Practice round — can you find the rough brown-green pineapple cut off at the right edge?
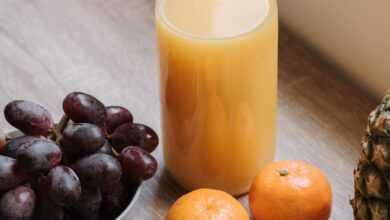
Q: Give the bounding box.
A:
[351,91,390,220]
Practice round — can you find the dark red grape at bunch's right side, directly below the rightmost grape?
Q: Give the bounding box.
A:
[119,147,157,181]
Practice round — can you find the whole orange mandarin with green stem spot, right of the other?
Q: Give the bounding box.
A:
[249,161,332,220]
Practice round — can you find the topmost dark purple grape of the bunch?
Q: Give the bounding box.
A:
[62,92,106,127]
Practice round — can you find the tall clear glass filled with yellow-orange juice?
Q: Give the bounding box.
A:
[156,0,278,195]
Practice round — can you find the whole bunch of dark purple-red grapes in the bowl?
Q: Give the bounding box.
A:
[0,92,159,220]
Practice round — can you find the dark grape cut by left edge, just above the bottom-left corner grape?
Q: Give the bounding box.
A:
[0,155,26,193]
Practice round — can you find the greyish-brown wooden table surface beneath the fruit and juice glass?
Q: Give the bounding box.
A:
[0,0,375,220]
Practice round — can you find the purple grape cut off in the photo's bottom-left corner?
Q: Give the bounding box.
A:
[0,186,36,220]
